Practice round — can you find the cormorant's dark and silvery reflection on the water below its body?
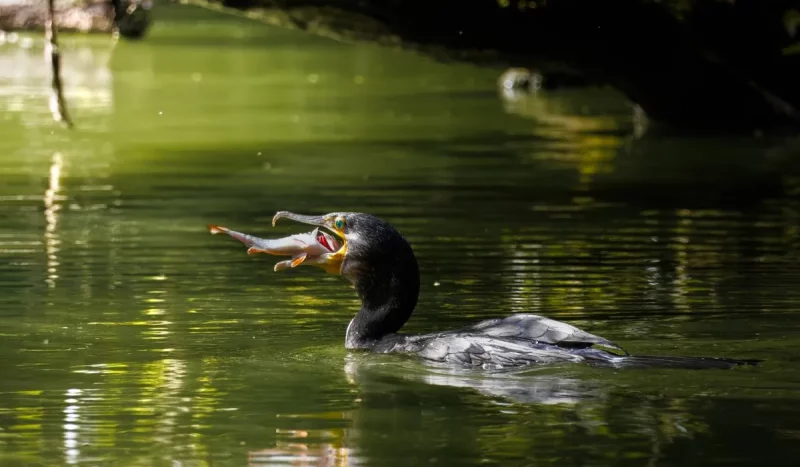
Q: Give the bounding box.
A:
[347,359,724,465]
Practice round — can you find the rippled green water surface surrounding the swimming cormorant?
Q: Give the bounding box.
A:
[0,7,800,466]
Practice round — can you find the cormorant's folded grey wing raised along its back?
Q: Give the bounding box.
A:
[464,314,628,355]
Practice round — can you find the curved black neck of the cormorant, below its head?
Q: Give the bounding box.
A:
[345,229,419,349]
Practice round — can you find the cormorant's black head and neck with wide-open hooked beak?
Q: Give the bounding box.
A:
[272,211,419,348]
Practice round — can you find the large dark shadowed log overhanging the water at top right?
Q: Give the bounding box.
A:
[209,0,800,129]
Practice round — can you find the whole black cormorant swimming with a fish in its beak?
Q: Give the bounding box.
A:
[210,211,758,369]
